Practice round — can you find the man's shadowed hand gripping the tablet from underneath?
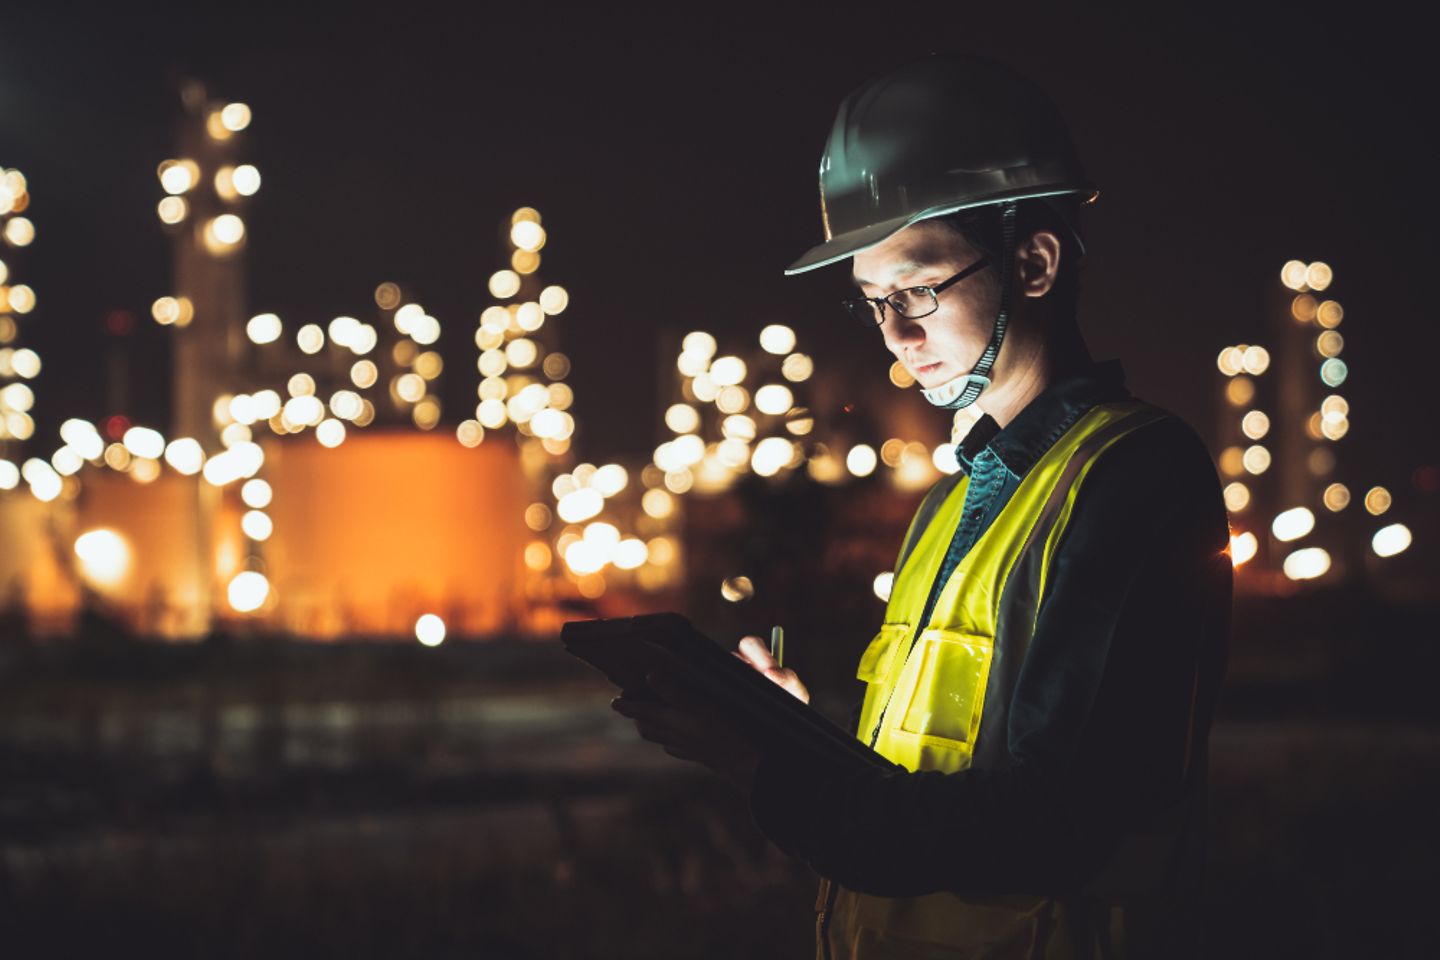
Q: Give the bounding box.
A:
[611,664,760,793]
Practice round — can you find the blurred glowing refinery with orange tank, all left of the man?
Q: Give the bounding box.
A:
[0,81,969,645]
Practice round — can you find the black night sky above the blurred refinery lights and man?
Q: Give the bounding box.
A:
[0,3,1440,486]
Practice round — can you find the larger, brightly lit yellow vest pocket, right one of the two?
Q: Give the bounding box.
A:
[900,629,995,754]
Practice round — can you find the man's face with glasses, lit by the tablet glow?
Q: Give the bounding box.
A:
[852,220,999,389]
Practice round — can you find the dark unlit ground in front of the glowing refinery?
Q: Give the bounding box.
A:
[0,590,1440,960]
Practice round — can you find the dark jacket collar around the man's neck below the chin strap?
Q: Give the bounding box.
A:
[955,360,1130,478]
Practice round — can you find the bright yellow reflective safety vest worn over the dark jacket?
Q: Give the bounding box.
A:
[815,399,1186,960]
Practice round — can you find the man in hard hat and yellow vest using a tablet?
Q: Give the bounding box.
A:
[616,56,1231,959]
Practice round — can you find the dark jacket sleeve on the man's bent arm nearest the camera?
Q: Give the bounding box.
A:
[750,417,1231,897]
